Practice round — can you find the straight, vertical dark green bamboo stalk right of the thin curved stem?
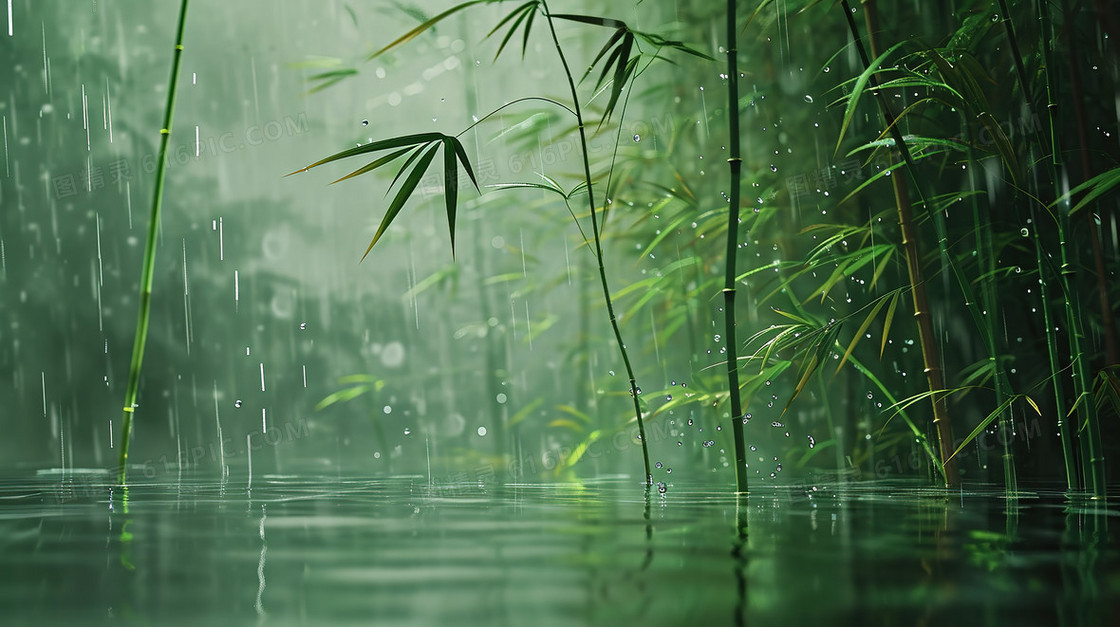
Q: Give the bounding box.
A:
[724,0,747,493]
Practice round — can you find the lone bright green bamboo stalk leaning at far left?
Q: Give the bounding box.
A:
[118,0,187,485]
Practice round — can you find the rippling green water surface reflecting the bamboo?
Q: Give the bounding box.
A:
[0,469,1120,626]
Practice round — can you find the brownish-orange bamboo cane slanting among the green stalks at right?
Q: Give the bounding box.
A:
[841,0,960,486]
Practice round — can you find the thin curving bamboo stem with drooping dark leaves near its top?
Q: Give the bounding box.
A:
[541,0,653,487]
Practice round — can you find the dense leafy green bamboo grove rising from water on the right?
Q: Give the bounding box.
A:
[282,0,1120,496]
